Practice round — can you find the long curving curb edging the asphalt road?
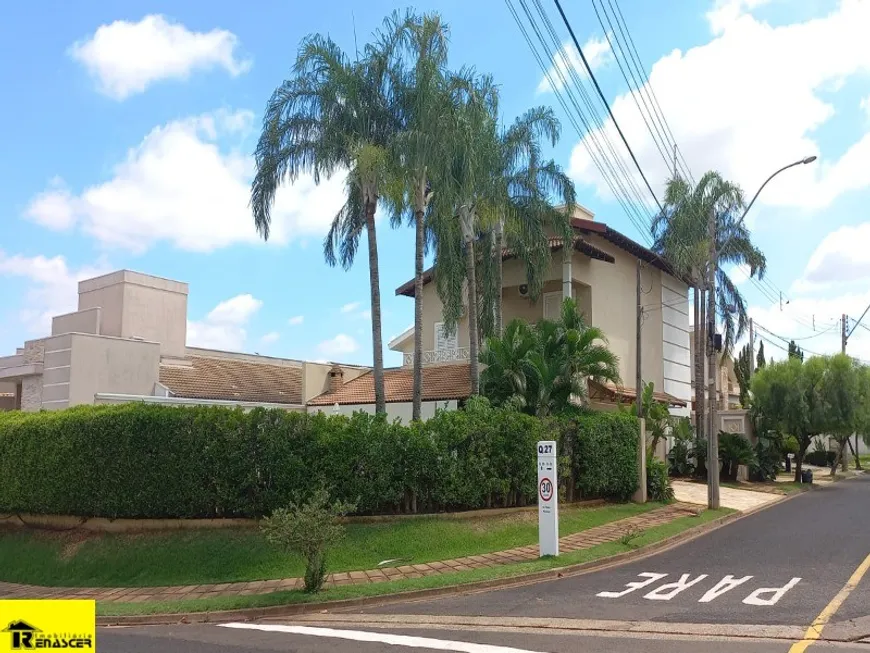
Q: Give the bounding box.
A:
[97,492,806,626]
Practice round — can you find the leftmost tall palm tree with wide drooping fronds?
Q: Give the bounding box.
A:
[251,24,400,413]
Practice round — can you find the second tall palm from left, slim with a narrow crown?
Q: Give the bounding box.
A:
[394,14,450,419]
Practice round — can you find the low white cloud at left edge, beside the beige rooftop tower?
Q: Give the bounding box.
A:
[0,251,111,336]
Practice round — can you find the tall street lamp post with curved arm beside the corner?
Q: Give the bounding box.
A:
[707,155,816,510]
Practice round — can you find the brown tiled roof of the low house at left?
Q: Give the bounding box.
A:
[160,356,302,404]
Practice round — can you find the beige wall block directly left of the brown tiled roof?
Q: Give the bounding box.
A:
[69,334,160,406]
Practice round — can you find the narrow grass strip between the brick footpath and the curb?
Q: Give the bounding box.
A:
[97,508,734,616]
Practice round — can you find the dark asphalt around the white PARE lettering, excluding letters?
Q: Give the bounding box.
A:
[356,477,870,626]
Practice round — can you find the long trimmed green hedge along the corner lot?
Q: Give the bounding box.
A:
[0,400,637,518]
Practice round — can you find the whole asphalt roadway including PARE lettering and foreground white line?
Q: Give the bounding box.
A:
[98,476,870,653]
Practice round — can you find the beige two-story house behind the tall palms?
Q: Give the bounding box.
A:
[316,207,691,415]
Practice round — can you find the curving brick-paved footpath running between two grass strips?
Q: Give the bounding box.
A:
[0,503,698,603]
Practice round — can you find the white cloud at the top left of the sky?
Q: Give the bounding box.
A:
[69,14,251,100]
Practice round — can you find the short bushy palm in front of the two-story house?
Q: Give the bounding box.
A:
[480,299,620,417]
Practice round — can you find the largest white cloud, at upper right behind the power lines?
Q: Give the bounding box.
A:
[570,0,870,216]
